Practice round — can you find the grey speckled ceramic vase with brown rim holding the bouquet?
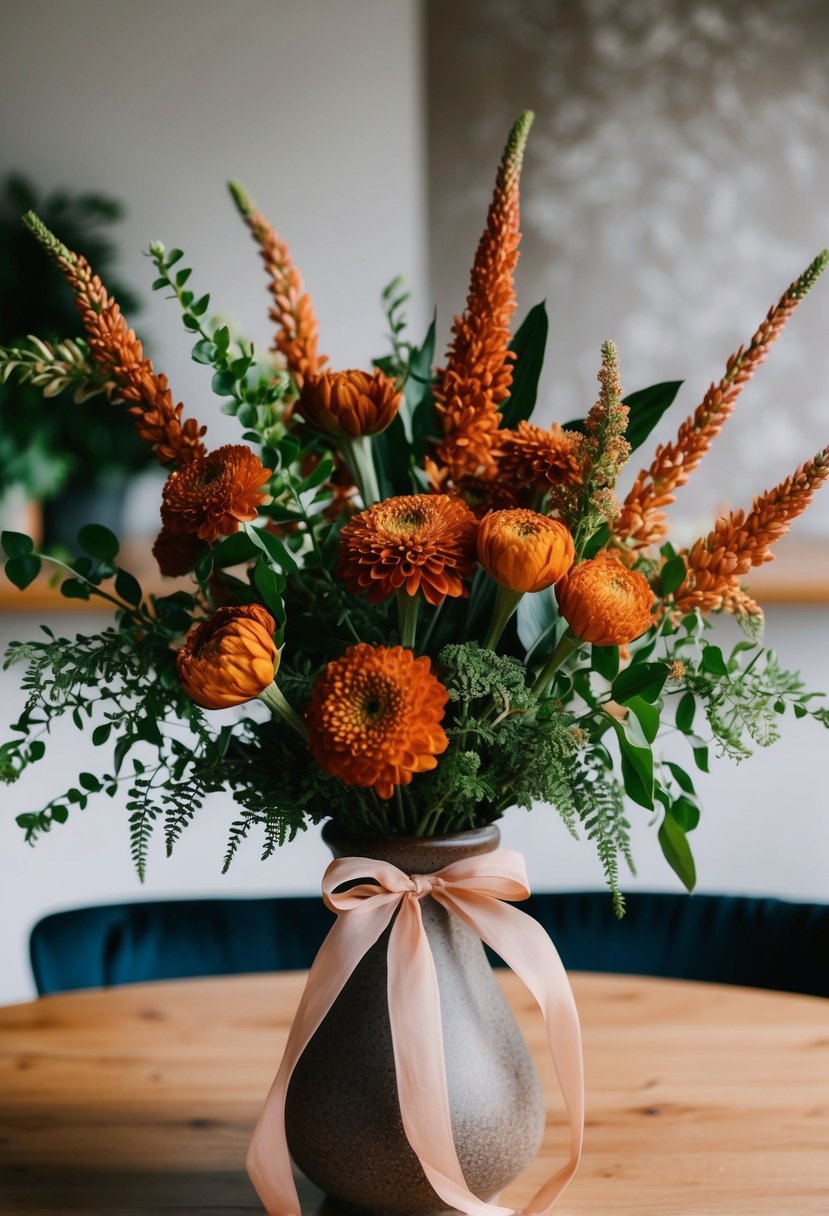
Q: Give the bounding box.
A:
[280,827,545,1216]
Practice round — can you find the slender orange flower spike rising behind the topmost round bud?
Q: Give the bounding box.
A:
[230,181,328,389]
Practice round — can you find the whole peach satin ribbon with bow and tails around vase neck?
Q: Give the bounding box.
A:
[247,849,585,1216]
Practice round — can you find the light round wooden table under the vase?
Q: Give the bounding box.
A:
[0,973,829,1216]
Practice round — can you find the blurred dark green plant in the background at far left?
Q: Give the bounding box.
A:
[0,174,148,547]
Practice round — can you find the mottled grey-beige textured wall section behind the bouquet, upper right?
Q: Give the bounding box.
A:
[427,0,829,536]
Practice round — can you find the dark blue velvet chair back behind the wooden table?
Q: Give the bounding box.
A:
[30,891,829,996]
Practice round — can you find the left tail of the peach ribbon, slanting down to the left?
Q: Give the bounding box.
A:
[247,900,399,1216]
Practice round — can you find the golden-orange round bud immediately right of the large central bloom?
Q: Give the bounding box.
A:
[478,508,575,592]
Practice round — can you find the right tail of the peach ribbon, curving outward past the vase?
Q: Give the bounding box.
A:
[432,888,585,1216]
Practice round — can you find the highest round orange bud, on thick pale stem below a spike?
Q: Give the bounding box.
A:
[298,371,402,439]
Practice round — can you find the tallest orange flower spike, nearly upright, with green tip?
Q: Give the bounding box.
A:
[435,111,534,482]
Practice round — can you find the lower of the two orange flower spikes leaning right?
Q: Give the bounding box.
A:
[673,446,829,613]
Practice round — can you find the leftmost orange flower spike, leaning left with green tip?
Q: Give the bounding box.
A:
[23,212,207,466]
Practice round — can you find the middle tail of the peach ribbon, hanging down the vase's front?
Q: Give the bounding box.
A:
[388,897,513,1216]
